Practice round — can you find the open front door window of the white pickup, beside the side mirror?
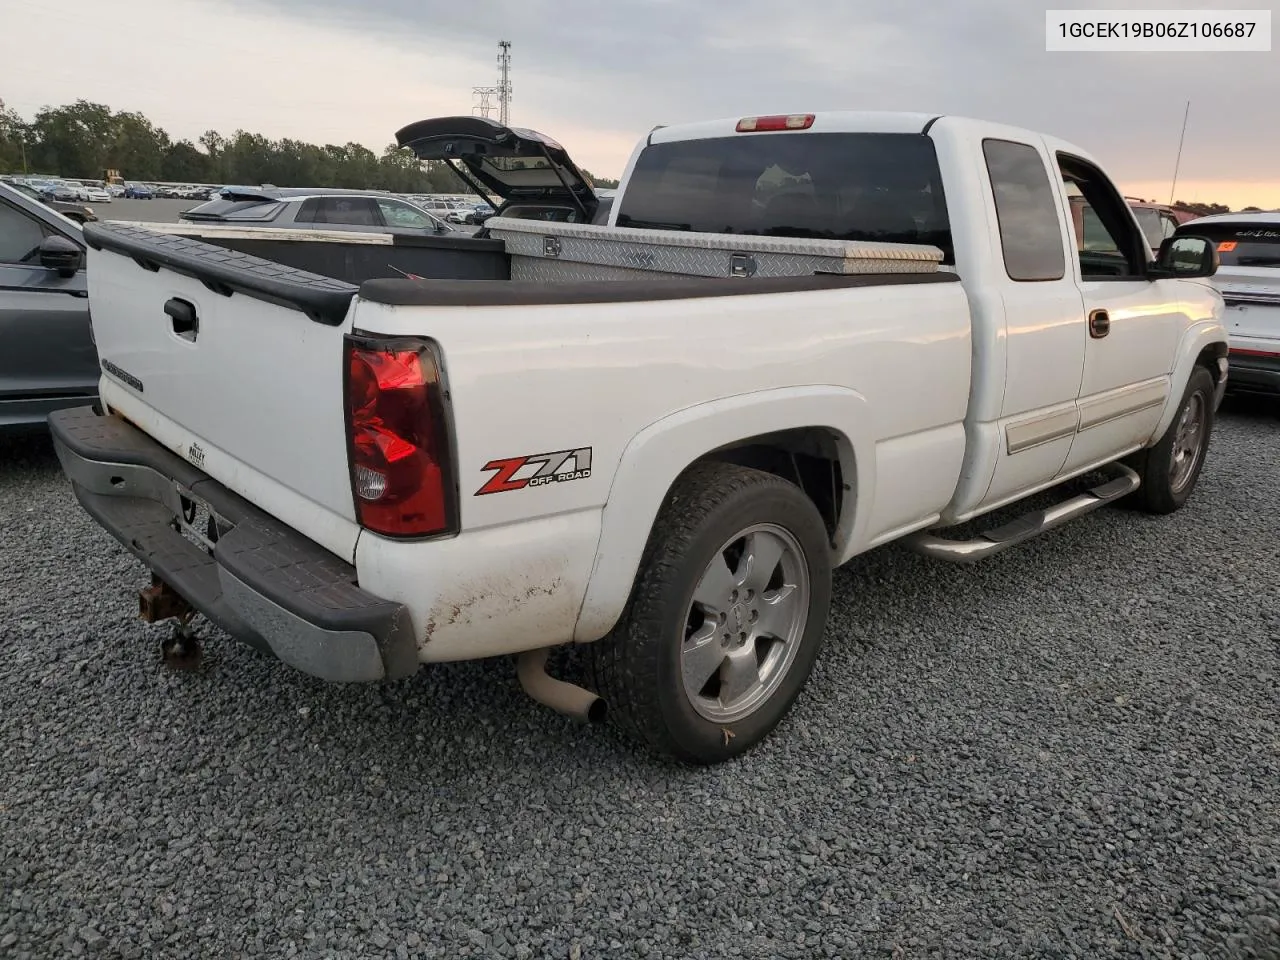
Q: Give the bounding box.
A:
[1057,154,1151,280]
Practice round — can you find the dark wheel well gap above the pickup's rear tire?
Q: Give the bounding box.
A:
[698,426,854,536]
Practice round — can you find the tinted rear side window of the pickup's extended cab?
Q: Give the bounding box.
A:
[982,140,1066,280]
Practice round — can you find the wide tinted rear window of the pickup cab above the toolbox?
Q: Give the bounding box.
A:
[617,133,954,264]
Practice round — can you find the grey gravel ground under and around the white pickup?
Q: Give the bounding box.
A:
[0,406,1280,960]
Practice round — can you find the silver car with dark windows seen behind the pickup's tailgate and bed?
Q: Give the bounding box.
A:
[180,187,453,237]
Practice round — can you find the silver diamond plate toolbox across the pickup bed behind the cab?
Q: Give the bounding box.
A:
[485,216,942,280]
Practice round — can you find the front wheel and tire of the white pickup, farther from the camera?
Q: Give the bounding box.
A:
[1128,366,1215,513]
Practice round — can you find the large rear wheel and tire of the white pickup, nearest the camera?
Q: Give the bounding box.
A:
[590,462,831,764]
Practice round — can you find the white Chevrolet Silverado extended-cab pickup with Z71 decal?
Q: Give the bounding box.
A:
[50,113,1228,763]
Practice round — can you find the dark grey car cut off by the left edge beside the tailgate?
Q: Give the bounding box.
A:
[0,184,100,428]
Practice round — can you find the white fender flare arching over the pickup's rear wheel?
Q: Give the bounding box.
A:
[573,385,876,643]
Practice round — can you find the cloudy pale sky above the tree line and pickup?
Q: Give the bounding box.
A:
[0,0,1280,209]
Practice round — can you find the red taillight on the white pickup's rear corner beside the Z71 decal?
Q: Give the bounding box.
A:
[343,335,458,538]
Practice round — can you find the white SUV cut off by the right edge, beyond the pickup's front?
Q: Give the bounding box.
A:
[1176,211,1280,396]
